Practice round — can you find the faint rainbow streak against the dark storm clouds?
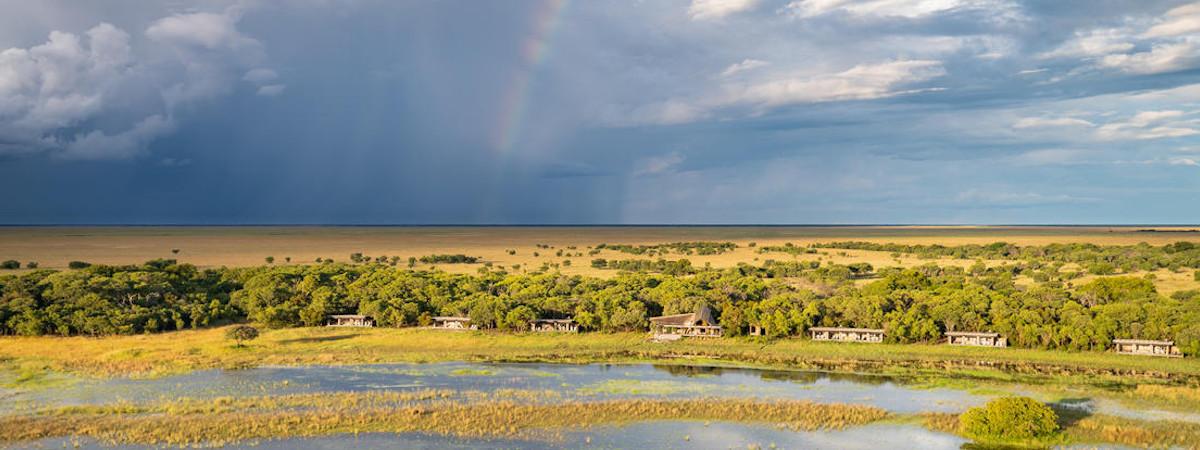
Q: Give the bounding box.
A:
[492,0,570,152]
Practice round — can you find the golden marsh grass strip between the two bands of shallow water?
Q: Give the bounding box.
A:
[0,391,888,445]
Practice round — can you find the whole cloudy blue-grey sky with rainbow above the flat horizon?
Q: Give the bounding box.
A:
[0,0,1200,224]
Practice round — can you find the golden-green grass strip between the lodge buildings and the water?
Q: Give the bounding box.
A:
[0,328,1200,388]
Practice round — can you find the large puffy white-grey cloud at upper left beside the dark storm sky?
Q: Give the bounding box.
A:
[0,8,282,160]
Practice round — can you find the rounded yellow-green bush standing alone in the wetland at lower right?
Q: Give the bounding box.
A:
[959,397,1058,439]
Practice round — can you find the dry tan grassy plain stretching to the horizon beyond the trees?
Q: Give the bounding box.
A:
[0,227,1200,294]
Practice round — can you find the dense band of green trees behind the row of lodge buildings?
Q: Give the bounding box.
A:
[0,260,1200,355]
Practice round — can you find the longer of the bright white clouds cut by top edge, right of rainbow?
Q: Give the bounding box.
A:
[782,0,1003,18]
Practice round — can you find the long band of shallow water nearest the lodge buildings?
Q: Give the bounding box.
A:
[0,362,986,413]
